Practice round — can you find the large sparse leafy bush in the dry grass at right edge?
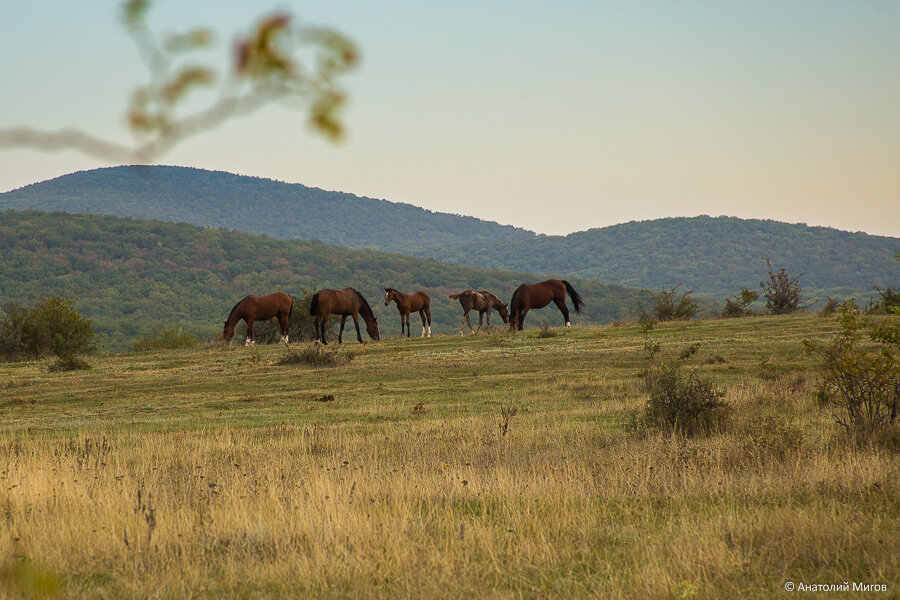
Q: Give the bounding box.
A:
[803,300,900,440]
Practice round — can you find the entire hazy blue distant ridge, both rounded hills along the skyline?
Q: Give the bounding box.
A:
[0,166,900,299]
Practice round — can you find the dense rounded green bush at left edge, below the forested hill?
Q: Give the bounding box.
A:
[0,296,95,361]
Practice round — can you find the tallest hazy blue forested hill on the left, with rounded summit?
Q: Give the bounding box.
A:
[0,166,535,250]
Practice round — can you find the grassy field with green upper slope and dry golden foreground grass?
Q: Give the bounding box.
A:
[0,316,900,598]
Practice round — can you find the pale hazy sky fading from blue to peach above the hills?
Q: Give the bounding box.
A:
[0,0,900,236]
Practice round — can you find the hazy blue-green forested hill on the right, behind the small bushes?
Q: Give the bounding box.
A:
[410,216,900,298]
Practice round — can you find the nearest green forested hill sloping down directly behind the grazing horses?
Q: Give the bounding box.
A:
[0,211,644,349]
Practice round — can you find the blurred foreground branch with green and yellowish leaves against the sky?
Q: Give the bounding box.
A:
[0,0,359,163]
